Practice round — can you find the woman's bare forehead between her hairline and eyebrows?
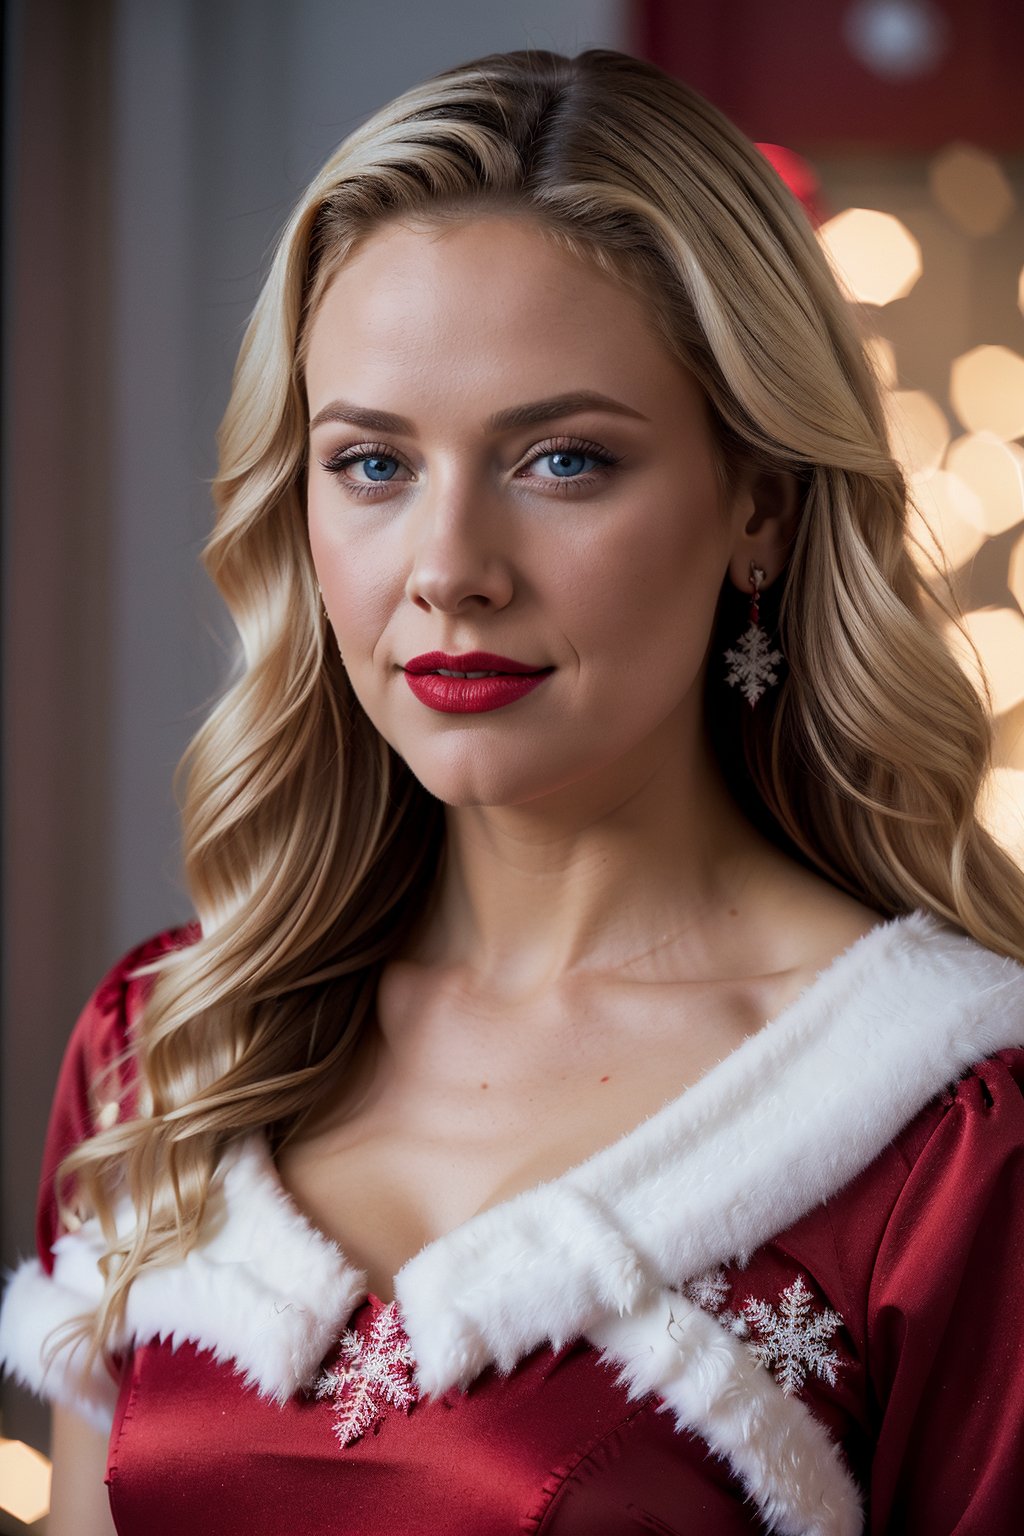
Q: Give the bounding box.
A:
[306,215,700,433]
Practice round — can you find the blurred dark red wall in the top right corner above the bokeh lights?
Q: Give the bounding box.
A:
[631,0,1024,154]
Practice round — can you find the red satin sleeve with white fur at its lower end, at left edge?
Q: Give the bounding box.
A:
[0,928,197,1427]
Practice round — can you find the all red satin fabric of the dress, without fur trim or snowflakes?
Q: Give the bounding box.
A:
[38,935,1024,1536]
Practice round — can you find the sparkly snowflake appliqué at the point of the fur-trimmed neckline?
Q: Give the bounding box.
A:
[316,1301,419,1445]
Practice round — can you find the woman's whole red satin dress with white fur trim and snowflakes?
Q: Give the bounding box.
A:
[0,912,1024,1536]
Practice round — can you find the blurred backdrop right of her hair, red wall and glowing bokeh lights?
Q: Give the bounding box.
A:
[641,0,1024,857]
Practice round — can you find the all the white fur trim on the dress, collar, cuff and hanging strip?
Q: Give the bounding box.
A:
[0,912,1024,1536]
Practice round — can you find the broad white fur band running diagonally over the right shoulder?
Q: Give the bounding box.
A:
[395,912,1024,1393]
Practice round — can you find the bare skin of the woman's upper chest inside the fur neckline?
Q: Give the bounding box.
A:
[278,968,798,1299]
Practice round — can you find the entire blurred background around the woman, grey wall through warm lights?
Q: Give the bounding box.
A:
[0,0,1024,1531]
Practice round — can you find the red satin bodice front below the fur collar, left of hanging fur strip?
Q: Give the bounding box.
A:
[107,1301,760,1536]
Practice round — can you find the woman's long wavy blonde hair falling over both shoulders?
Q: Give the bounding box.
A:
[60,49,1024,1355]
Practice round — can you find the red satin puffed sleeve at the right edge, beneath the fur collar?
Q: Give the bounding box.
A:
[867,1049,1024,1536]
